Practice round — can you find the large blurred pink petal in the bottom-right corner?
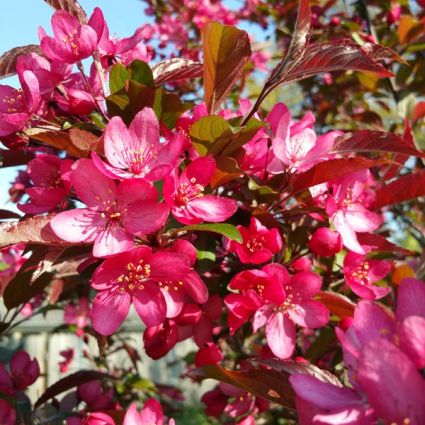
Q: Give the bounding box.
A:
[358,339,425,425]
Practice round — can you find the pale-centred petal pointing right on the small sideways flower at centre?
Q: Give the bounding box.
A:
[187,195,238,223]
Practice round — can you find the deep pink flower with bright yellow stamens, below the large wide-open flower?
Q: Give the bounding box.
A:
[92,246,190,335]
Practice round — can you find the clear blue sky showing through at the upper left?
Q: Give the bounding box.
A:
[0,0,152,210]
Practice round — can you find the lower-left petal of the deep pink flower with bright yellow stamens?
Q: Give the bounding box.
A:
[92,290,131,335]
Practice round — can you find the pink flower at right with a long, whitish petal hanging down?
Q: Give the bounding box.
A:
[326,170,382,254]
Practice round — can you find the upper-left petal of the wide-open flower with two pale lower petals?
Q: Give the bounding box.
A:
[71,159,116,211]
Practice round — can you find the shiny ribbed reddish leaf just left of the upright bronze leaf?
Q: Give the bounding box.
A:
[152,58,203,86]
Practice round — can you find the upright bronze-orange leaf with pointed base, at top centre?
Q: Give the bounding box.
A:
[201,22,251,113]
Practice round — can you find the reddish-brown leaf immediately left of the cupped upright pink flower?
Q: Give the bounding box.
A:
[25,127,100,158]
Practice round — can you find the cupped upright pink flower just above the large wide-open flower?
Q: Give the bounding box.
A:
[92,108,183,181]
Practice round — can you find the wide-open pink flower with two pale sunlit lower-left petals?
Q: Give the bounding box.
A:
[51,159,169,257]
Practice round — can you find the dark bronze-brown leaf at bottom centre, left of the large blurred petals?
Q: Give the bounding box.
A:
[188,364,295,409]
